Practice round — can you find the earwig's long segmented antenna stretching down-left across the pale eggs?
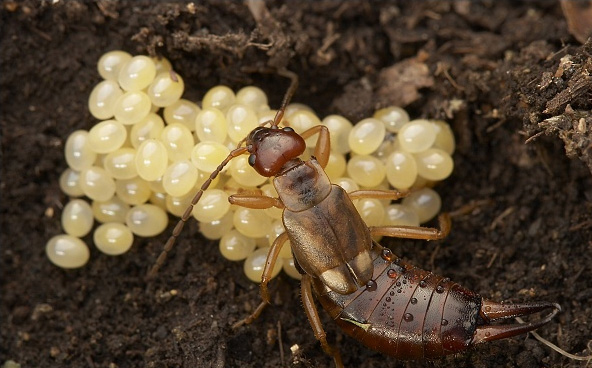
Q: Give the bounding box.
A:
[148,145,247,279]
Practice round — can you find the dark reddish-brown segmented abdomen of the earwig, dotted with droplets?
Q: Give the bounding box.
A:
[314,245,482,359]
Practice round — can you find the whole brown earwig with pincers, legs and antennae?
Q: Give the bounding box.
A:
[150,71,561,367]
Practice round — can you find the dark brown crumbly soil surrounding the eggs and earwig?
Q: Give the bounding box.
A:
[0,0,592,368]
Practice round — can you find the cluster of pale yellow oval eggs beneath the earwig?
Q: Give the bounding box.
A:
[46,51,454,282]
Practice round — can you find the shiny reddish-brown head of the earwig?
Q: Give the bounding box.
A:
[246,126,306,177]
